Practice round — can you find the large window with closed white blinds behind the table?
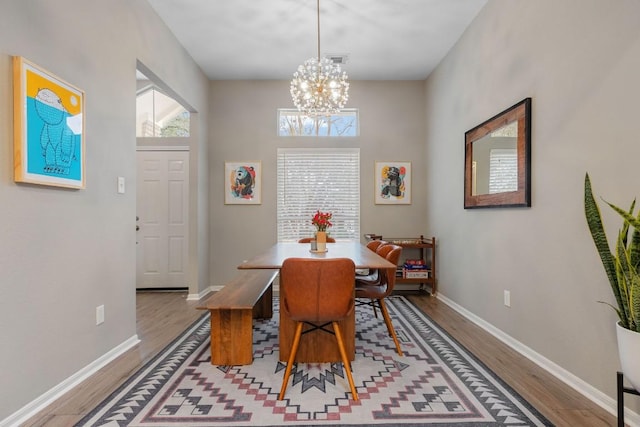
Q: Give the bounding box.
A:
[277,148,360,242]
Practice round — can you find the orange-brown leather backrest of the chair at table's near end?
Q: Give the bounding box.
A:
[280,258,356,322]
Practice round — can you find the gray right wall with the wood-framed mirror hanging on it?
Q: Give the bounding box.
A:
[424,0,640,412]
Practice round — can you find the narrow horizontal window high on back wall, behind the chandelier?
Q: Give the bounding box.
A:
[278,108,359,137]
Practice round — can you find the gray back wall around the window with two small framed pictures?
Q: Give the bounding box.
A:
[209,81,429,285]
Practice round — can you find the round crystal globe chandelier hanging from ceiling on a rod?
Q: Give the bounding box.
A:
[290,0,349,116]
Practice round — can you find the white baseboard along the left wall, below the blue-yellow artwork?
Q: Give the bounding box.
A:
[0,335,140,427]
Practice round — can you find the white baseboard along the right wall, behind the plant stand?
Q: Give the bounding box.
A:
[438,293,640,427]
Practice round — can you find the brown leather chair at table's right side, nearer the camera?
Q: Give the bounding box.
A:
[356,244,402,356]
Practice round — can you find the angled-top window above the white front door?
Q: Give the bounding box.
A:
[136,85,190,138]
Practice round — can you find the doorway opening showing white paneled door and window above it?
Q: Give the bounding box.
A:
[136,61,194,291]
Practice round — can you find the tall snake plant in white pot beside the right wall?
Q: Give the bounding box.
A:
[584,174,640,390]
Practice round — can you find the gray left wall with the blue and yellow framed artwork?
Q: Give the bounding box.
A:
[0,0,208,420]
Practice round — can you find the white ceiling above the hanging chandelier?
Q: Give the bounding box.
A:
[148,0,487,80]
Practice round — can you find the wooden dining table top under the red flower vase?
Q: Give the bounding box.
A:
[238,242,396,270]
